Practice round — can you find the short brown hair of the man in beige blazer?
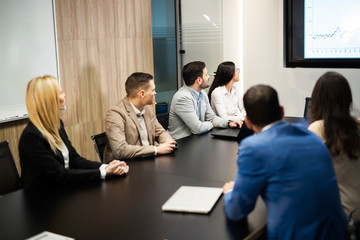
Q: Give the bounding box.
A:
[125,72,154,97]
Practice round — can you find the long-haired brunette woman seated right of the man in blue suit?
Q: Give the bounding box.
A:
[309,72,360,218]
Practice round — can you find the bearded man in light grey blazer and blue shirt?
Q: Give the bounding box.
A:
[169,61,242,139]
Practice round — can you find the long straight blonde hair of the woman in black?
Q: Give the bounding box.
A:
[26,75,63,153]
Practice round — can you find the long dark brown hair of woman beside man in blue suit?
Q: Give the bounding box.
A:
[311,72,360,159]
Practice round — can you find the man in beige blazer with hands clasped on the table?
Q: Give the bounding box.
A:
[104,72,176,162]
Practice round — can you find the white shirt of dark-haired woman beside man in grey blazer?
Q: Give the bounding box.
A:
[211,85,246,121]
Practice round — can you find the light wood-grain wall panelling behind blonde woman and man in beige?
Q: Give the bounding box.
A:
[0,0,154,174]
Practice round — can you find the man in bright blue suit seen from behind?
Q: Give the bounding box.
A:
[223,85,346,239]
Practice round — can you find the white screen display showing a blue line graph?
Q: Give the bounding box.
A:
[304,0,360,58]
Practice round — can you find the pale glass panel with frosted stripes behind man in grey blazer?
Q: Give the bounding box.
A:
[179,0,223,89]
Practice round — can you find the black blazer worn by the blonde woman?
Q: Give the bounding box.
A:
[19,120,101,188]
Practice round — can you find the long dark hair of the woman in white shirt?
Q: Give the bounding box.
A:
[208,62,235,101]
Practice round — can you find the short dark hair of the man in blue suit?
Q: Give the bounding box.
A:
[244,84,282,127]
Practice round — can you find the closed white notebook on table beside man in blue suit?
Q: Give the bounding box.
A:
[162,186,222,214]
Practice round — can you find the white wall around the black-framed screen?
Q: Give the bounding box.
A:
[223,0,360,117]
